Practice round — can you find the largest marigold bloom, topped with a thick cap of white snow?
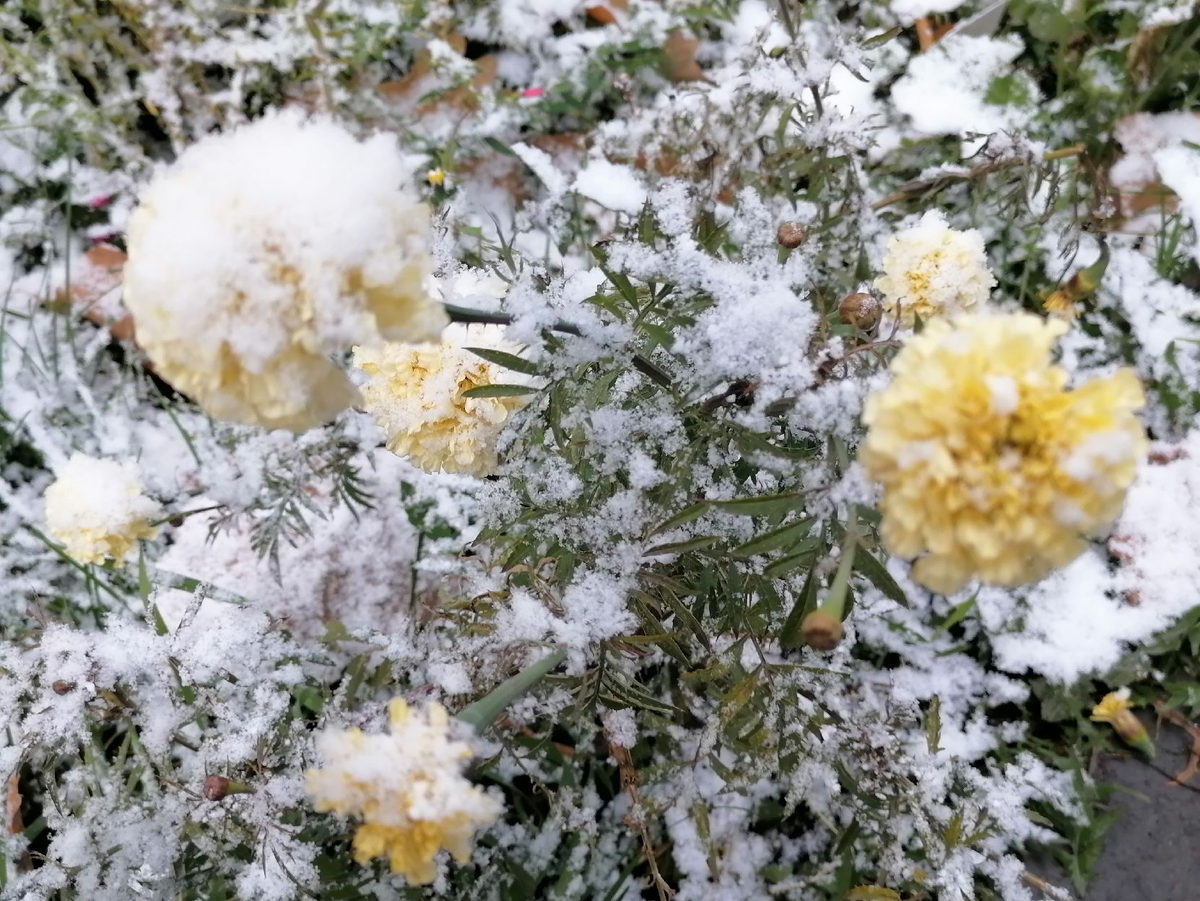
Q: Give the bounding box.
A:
[125,112,445,431]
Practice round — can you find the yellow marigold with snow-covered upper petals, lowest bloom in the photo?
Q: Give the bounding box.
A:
[307,698,502,885]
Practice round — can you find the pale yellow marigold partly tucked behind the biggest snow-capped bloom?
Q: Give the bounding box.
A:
[354,325,528,475]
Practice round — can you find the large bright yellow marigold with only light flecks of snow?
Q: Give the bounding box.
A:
[860,313,1146,594]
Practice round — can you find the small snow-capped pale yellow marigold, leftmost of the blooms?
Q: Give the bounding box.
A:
[46,453,160,563]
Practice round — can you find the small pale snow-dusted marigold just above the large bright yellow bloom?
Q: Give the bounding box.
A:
[875,210,996,325]
